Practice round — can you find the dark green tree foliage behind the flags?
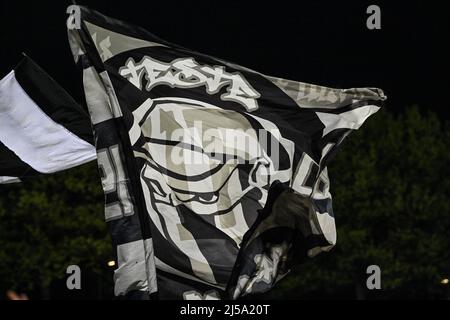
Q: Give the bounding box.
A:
[0,107,450,299]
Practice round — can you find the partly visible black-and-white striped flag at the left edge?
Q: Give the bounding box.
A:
[0,56,96,184]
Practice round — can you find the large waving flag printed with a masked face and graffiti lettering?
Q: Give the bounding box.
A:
[68,7,386,300]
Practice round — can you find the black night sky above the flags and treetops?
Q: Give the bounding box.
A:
[0,0,450,119]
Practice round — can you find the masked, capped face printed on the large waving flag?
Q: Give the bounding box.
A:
[133,98,294,280]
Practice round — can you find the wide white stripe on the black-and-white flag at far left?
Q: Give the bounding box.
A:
[0,71,96,173]
